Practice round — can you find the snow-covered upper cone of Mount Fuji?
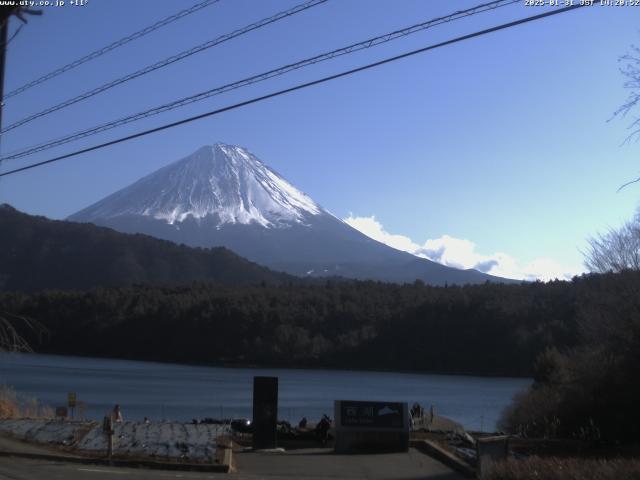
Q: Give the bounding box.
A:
[76,143,326,228]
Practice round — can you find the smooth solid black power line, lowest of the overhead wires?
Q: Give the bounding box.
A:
[0,3,589,177]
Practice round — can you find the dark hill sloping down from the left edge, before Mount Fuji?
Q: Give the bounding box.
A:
[0,204,295,291]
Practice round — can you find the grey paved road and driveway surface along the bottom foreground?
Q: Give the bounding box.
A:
[0,449,463,480]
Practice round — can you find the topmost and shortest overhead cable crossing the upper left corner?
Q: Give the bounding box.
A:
[3,0,220,100]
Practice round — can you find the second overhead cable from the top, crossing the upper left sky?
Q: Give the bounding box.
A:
[0,0,328,134]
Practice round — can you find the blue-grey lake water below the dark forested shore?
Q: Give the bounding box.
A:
[0,353,531,431]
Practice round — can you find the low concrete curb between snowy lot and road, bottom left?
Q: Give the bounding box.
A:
[0,449,232,473]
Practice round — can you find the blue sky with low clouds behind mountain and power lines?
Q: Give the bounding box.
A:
[0,0,640,278]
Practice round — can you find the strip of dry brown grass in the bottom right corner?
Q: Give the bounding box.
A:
[488,457,640,480]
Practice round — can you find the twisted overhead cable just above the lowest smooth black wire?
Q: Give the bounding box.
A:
[0,0,520,162]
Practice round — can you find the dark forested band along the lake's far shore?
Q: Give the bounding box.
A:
[5,272,640,375]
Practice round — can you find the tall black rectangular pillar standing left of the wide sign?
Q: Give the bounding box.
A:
[253,377,278,449]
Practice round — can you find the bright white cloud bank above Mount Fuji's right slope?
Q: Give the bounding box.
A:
[344,214,583,281]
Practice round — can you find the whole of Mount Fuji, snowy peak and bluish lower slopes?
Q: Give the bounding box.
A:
[68,143,508,285]
